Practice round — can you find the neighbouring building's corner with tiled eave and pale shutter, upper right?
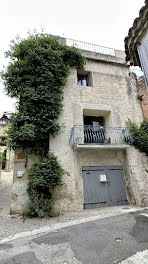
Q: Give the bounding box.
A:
[125,0,148,89]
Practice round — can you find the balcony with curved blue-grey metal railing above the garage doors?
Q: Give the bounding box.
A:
[69,126,133,149]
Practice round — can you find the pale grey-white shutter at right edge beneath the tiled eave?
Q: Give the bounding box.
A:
[138,40,148,89]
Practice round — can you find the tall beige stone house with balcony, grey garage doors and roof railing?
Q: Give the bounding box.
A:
[11,37,148,213]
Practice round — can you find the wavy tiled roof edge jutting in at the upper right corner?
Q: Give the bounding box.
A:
[124,0,148,65]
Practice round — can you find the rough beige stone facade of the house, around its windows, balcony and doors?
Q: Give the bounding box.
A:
[11,46,148,212]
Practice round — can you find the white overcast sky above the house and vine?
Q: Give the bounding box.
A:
[0,0,145,117]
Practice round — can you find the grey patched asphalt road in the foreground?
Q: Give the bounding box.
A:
[0,209,148,264]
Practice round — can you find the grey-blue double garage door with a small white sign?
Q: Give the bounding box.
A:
[83,166,127,208]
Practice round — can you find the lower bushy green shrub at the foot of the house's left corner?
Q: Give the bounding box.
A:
[24,153,66,217]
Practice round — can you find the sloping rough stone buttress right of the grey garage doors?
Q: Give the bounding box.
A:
[125,146,148,206]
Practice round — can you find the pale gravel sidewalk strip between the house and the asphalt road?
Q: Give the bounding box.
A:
[0,172,147,240]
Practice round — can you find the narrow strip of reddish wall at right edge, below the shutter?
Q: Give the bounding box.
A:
[138,76,148,121]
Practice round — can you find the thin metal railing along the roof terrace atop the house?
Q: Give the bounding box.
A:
[66,39,115,56]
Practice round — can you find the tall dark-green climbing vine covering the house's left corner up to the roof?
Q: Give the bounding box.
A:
[2,34,85,216]
